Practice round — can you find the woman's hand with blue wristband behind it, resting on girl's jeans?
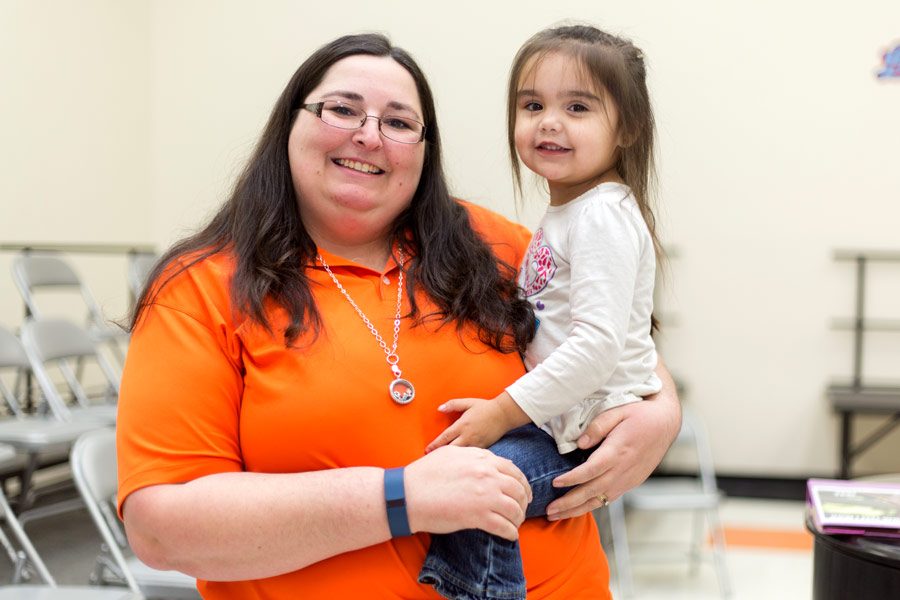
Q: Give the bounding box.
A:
[404,446,531,540]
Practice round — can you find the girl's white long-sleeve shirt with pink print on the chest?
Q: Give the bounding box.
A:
[506,183,662,453]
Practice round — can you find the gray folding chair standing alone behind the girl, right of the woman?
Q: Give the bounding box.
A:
[609,407,732,598]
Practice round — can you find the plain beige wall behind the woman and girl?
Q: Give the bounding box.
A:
[0,0,900,476]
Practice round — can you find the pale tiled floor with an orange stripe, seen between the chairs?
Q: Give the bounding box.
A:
[0,482,812,600]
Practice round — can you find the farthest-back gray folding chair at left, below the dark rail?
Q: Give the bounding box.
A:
[12,252,129,368]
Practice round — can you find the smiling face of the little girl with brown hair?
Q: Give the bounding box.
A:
[514,52,621,205]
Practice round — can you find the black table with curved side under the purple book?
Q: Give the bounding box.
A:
[806,515,900,600]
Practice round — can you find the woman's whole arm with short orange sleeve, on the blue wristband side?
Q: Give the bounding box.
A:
[117,256,530,580]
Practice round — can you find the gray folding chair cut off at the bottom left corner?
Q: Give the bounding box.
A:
[0,444,142,600]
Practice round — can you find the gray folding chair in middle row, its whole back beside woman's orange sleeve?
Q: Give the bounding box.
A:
[21,319,119,425]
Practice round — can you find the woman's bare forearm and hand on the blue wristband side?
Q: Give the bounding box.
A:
[123,447,531,581]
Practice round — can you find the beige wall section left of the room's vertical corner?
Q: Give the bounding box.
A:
[0,0,156,327]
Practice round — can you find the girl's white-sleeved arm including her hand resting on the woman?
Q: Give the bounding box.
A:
[426,199,655,451]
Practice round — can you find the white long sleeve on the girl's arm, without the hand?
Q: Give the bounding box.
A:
[506,197,655,426]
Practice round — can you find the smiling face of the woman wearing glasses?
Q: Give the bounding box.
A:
[288,55,428,253]
